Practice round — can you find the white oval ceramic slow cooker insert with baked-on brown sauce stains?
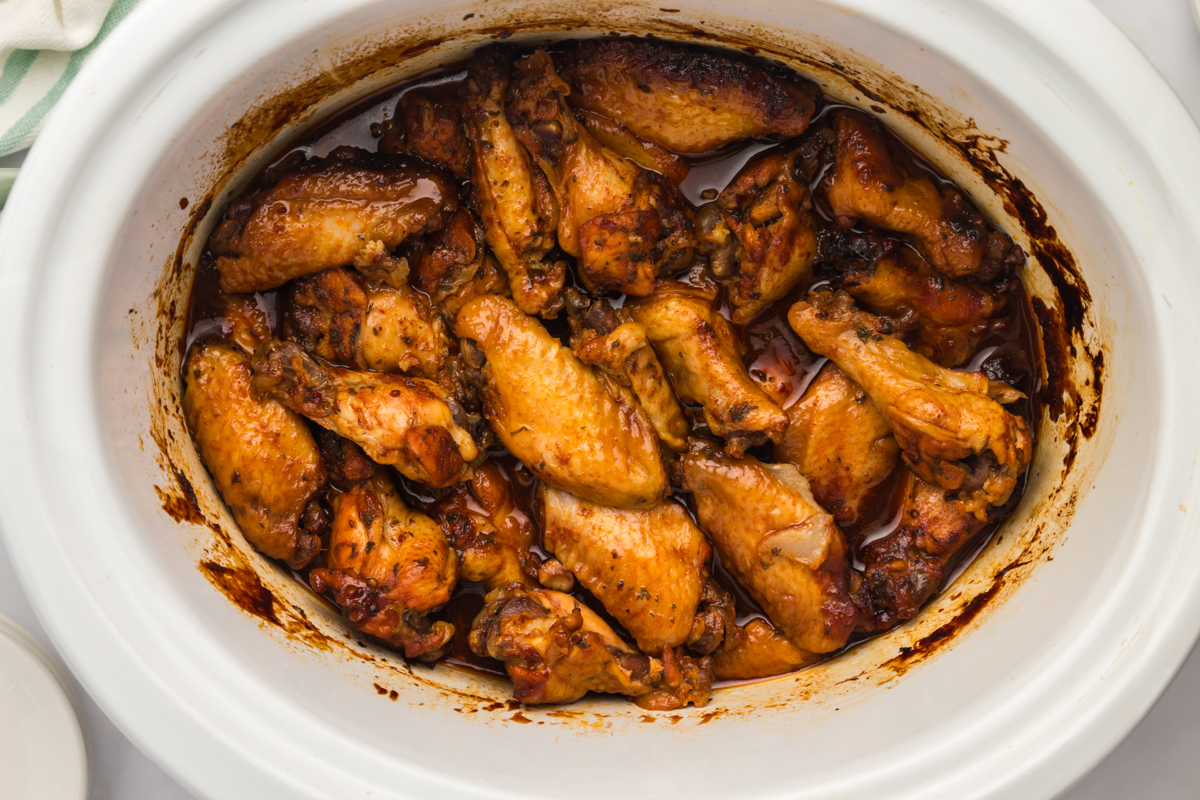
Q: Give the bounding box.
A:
[0,0,1200,800]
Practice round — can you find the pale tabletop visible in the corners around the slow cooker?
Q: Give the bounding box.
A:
[0,0,1200,800]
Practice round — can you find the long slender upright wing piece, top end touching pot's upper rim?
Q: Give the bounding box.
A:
[463,46,566,317]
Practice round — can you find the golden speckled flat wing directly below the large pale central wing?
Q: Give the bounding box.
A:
[538,486,724,655]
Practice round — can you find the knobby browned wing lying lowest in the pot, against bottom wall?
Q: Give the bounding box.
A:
[470,587,713,710]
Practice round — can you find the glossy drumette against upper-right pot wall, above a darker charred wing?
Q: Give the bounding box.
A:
[821,109,1025,281]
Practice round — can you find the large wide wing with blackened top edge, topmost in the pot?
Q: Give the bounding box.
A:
[558,38,820,155]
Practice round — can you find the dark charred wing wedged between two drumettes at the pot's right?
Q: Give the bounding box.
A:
[839,241,1008,367]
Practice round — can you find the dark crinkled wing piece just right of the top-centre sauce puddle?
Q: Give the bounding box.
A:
[696,152,817,325]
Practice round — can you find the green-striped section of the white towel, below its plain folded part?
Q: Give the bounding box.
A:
[0,0,138,158]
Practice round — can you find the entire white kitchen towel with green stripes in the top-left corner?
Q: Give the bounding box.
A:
[0,0,138,156]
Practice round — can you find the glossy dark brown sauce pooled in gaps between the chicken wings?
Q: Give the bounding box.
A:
[180,47,1042,686]
